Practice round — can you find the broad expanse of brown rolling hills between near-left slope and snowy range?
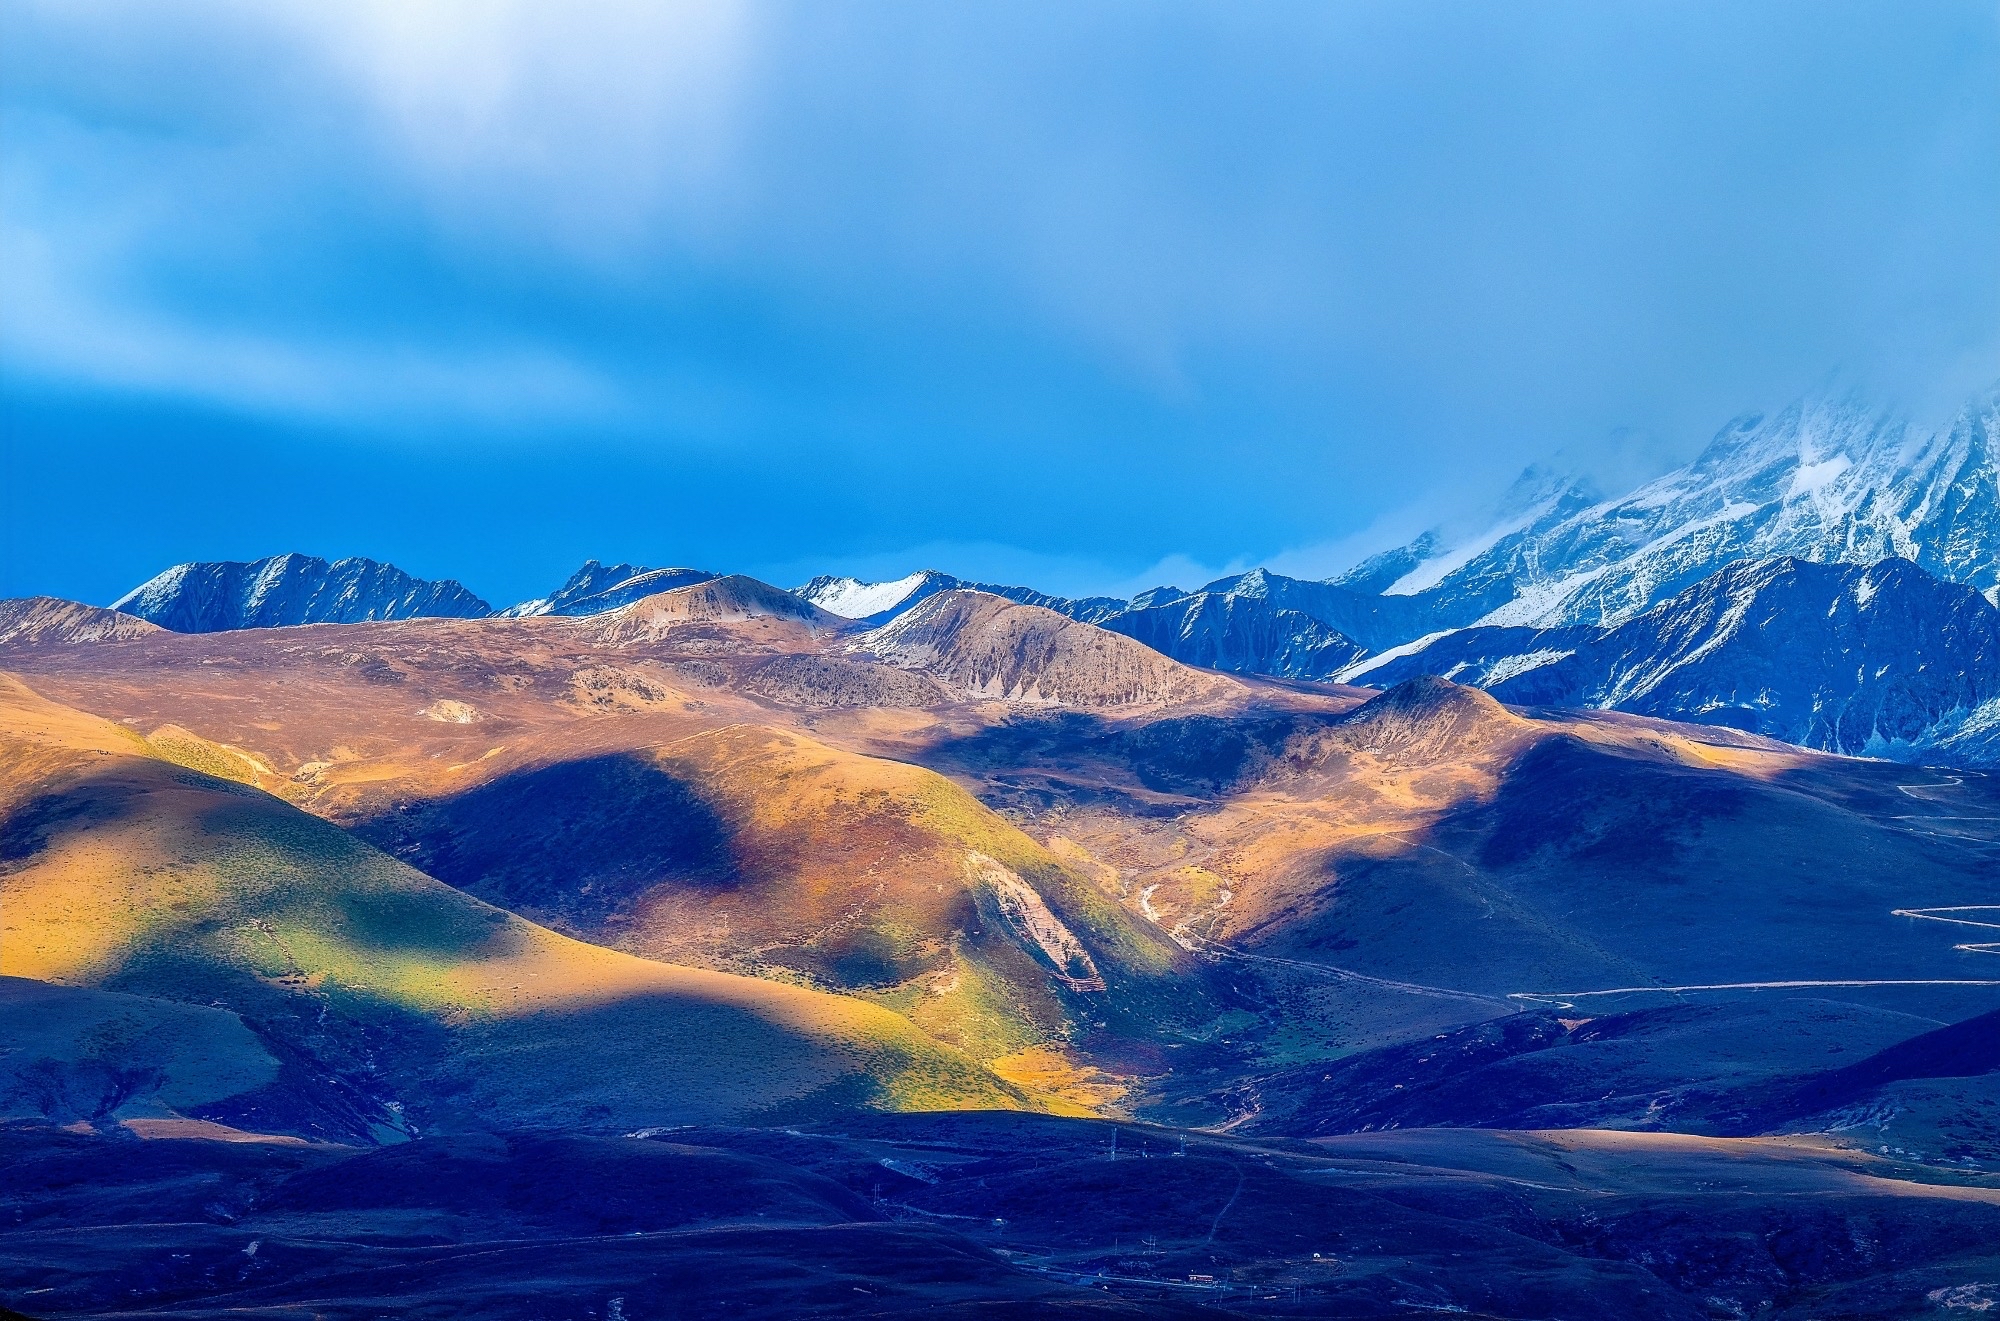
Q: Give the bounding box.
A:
[8,580,2000,1123]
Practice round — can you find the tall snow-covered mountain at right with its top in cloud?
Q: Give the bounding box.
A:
[1334,388,2000,628]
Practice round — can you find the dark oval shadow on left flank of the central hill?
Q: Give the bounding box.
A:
[354,753,740,925]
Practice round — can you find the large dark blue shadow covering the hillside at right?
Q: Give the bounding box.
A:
[1248,737,2000,993]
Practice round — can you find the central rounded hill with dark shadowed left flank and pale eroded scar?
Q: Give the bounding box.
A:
[368,725,1202,1059]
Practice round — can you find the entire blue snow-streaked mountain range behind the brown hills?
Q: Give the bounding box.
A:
[78,378,2000,765]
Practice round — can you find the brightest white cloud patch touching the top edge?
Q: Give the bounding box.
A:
[278,0,756,256]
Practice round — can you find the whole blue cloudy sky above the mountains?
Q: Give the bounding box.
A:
[0,0,2000,602]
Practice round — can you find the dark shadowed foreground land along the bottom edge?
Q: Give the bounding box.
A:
[0,1115,2000,1321]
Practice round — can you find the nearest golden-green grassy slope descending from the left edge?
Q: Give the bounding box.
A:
[0,681,1028,1125]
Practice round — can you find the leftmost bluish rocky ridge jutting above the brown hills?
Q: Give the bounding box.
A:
[112,554,492,632]
